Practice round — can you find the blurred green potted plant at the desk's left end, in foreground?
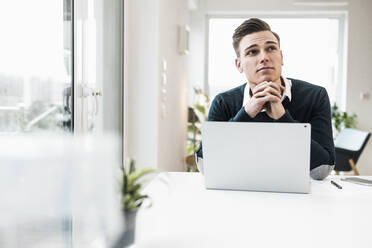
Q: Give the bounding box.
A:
[114,159,154,248]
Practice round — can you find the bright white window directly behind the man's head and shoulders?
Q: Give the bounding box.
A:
[207,16,345,105]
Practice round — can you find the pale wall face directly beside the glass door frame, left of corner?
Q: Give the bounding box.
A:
[124,0,159,167]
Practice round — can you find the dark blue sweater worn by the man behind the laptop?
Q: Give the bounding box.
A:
[197,79,335,169]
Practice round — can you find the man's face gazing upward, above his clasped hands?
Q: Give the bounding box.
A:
[235,31,283,88]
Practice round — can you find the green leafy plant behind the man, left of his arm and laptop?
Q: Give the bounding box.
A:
[186,88,210,172]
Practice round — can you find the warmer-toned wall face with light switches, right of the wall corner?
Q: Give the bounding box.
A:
[158,0,188,171]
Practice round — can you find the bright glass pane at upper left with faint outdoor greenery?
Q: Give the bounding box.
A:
[0,0,72,133]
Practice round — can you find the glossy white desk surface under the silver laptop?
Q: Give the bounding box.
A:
[136,173,372,248]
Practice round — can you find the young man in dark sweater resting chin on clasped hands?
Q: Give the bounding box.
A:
[197,18,335,180]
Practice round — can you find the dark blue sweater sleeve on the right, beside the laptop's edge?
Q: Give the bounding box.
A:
[277,88,335,173]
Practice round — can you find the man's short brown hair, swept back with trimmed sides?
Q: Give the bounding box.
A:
[232,18,280,57]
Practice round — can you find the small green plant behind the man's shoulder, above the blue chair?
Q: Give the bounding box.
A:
[331,103,357,137]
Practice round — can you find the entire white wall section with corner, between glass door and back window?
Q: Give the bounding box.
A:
[124,0,187,171]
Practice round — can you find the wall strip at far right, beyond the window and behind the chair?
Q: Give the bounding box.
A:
[346,0,372,175]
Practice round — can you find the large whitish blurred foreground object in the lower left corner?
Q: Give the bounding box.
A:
[0,135,122,248]
